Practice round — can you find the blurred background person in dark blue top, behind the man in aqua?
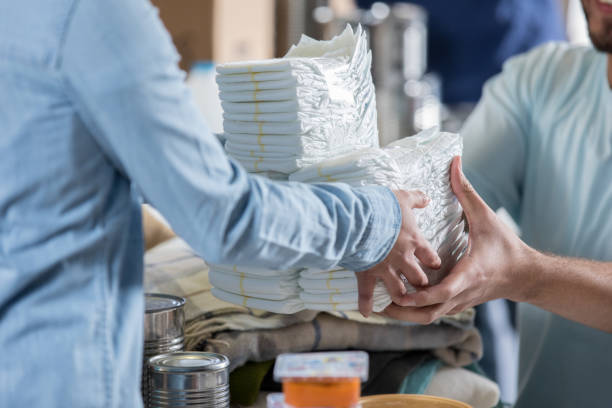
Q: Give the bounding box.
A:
[356,0,565,400]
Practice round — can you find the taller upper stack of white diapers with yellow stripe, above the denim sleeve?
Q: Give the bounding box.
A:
[217,26,378,174]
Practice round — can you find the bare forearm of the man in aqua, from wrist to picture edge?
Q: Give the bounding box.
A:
[514,250,612,332]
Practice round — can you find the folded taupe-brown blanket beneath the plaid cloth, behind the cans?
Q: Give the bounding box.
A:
[203,313,482,370]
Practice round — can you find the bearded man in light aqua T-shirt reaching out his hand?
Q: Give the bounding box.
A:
[388,0,612,407]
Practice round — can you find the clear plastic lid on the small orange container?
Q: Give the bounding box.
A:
[274,351,368,381]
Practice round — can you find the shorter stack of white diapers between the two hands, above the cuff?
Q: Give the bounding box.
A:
[289,128,468,290]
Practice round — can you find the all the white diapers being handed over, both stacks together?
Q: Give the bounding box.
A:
[209,26,467,313]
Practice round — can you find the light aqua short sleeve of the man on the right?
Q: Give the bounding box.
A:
[461,48,534,220]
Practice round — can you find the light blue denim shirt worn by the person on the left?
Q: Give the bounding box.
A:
[0,0,401,408]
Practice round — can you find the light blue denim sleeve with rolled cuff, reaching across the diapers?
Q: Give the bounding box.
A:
[58,0,401,271]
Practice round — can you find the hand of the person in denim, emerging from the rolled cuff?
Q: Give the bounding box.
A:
[357,190,441,317]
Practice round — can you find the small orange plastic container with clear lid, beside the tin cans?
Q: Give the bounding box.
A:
[274,351,368,408]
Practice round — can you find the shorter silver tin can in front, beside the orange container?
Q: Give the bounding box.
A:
[149,352,230,408]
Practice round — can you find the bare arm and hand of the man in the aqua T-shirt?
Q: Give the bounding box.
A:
[386,158,612,332]
